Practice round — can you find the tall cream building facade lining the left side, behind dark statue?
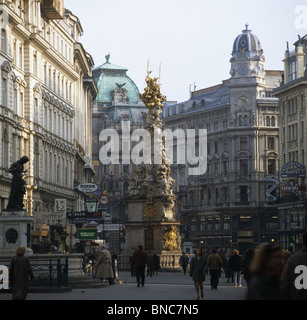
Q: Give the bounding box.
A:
[0,0,97,254]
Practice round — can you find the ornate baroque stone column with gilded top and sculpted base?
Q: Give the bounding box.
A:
[124,71,181,256]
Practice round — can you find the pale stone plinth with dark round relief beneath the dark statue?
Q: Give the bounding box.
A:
[0,210,34,255]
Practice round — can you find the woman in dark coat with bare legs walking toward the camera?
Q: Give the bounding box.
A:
[190,248,207,300]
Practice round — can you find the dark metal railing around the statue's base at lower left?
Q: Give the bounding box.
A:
[0,258,68,288]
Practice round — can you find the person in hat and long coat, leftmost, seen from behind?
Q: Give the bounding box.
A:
[9,247,34,300]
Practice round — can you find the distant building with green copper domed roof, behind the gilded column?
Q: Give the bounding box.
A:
[93,55,147,235]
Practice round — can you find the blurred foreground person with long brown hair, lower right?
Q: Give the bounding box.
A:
[247,243,281,300]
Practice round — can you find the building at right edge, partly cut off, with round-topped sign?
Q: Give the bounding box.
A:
[274,35,307,249]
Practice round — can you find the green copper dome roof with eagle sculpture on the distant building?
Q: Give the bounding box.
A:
[93,55,140,105]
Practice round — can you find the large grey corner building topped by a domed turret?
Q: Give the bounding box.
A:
[163,26,282,252]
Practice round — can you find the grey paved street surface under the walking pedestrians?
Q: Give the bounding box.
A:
[0,272,247,302]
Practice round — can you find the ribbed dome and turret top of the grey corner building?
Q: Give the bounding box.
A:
[230,24,265,81]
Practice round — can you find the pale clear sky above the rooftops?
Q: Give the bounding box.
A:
[64,0,307,102]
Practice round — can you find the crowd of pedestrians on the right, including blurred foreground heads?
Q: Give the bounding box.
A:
[184,233,307,300]
